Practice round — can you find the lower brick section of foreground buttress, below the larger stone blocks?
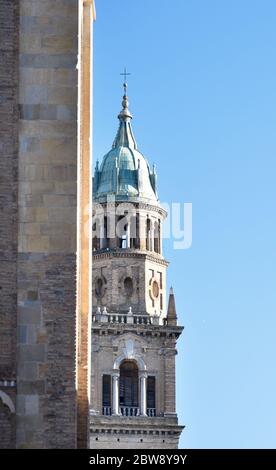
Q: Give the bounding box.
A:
[17,253,76,448]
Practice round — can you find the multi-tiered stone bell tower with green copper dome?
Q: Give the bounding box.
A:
[90,83,183,449]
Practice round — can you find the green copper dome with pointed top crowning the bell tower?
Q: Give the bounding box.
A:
[93,94,158,202]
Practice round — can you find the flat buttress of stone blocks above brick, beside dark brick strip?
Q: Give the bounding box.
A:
[17,0,78,448]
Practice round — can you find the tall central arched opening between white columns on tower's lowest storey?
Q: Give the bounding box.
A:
[120,360,139,416]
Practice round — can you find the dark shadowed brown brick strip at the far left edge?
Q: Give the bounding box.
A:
[0,0,19,448]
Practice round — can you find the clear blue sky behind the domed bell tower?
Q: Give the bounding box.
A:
[94,0,276,448]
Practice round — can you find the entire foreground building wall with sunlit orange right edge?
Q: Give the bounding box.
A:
[0,0,93,448]
